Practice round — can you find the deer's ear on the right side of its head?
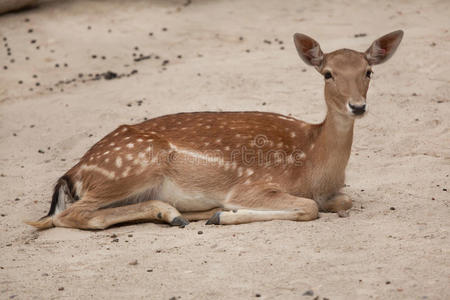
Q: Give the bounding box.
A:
[365,30,403,65]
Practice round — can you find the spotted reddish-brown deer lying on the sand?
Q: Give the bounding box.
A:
[28,30,403,229]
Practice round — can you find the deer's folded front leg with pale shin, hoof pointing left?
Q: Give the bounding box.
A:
[206,192,319,225]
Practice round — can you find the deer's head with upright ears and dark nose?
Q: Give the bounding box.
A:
[294,30,403,119]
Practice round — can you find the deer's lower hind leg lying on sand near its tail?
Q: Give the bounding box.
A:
[53,200,189,229]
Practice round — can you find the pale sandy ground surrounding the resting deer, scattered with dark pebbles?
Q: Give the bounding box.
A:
[0,0,450,299]
